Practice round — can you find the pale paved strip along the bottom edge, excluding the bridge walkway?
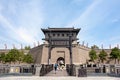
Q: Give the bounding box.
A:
[0,76,120,80]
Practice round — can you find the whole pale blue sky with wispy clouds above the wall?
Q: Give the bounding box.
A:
[0,0,120,48]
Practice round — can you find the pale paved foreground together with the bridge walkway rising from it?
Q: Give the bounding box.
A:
[0,70,120,80]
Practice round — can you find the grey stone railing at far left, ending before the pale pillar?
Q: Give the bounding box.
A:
[0,64,36,75]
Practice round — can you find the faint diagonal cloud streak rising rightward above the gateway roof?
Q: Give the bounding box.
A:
[67,0,102,30]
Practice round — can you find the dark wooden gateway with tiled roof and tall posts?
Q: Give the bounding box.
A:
[42,28,80,64]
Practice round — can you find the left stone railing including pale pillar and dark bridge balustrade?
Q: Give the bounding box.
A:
[0,64,53,76]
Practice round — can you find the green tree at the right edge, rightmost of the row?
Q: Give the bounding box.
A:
[110,47,120,64]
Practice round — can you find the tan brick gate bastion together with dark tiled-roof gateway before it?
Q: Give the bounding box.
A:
[30,28,89,64]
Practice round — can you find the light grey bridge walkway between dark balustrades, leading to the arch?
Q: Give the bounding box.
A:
[45,69,68,77]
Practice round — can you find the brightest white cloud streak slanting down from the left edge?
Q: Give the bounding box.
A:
[0,15,41,47]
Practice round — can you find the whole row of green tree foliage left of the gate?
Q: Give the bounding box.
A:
[0,49,33,63]
